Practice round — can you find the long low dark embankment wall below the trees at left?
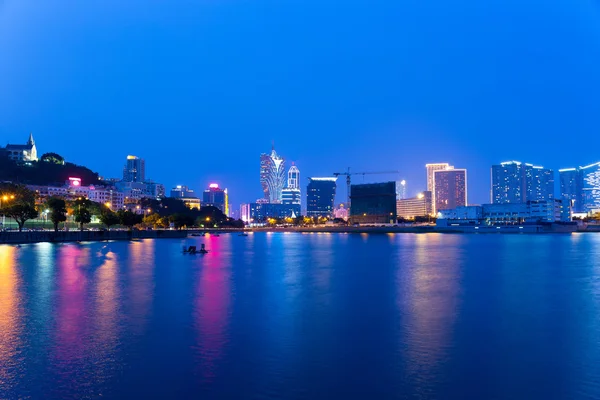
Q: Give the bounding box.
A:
[0,230,187,244]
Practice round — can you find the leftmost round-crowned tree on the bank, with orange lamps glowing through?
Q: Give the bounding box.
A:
[0,183,38,232]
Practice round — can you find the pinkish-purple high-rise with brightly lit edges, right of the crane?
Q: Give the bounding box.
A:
[432,169,467,213]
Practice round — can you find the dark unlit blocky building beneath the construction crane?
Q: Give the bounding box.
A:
[350,182,396,224]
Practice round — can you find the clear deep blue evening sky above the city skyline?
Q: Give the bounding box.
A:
[0,0,600,209]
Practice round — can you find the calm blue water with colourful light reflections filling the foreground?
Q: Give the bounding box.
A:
[0,233,600,399]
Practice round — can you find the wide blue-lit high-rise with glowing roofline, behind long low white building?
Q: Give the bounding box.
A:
[491,161,554,204]
